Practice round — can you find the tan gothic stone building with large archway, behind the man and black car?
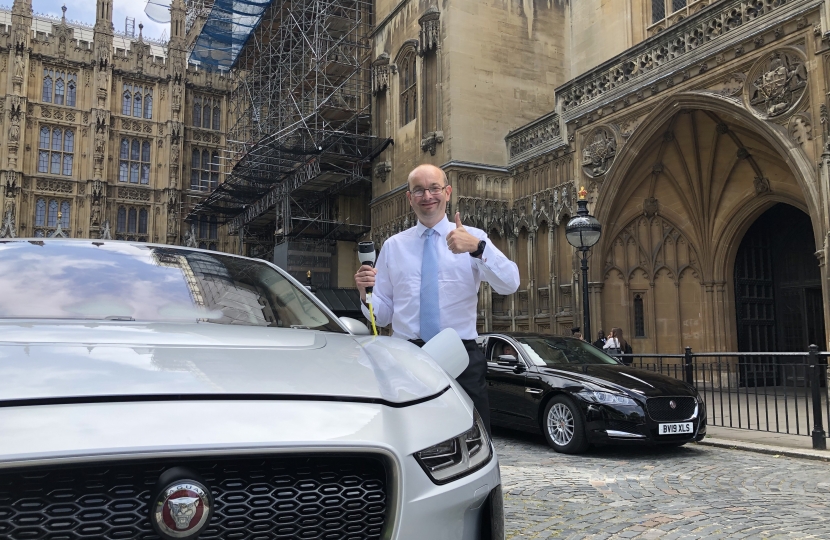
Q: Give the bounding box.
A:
[371,0,830,353]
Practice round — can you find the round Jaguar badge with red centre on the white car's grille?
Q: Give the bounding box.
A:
[150,478,213,540]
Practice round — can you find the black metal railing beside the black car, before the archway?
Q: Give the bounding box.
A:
[620,345,830,450]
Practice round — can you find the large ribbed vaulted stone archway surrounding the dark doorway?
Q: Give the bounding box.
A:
[595,101,823,353]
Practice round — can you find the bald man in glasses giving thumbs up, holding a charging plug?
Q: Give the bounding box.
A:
[355,165,519,432]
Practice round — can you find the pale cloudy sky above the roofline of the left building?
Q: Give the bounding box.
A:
[33,0,170,38]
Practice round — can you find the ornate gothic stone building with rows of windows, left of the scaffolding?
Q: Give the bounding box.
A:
[0,0,235,251]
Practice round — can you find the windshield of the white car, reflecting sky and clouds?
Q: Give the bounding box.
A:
[0,240,343,332]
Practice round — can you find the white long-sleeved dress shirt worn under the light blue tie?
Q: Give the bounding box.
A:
[363,216,519,339]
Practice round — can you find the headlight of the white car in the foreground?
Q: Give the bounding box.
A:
[415,413,493,485]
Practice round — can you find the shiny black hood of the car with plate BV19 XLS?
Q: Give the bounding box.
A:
[541,364,694,397]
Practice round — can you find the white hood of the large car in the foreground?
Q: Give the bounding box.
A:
[0,321,449,406]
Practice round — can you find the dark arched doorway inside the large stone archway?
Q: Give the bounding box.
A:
[735,203,825,352]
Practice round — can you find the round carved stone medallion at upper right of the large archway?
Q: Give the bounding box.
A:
[747,49,807,119]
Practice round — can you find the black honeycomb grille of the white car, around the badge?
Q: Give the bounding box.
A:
[0,455,387,540]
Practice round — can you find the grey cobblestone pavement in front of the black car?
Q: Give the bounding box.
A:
[495,430,830,540]
